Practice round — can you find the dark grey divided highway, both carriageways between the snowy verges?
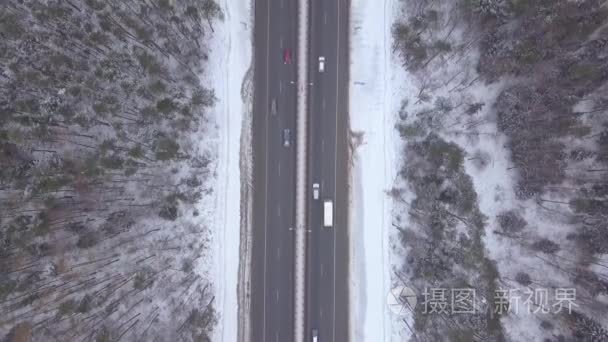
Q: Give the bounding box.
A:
[251,0,349,342]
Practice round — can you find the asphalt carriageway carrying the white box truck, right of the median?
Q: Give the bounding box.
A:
[306,0,349,342]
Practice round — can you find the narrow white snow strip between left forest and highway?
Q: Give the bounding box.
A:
[209,0,252,342]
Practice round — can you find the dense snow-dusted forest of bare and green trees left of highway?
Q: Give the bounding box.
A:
[0,0,223,342]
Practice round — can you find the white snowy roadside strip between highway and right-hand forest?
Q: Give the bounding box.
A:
[349,0,410,341]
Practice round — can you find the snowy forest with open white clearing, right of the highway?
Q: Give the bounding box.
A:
[389,0,608,341]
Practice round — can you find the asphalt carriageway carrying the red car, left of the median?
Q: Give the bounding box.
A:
[251,0,297,342]
